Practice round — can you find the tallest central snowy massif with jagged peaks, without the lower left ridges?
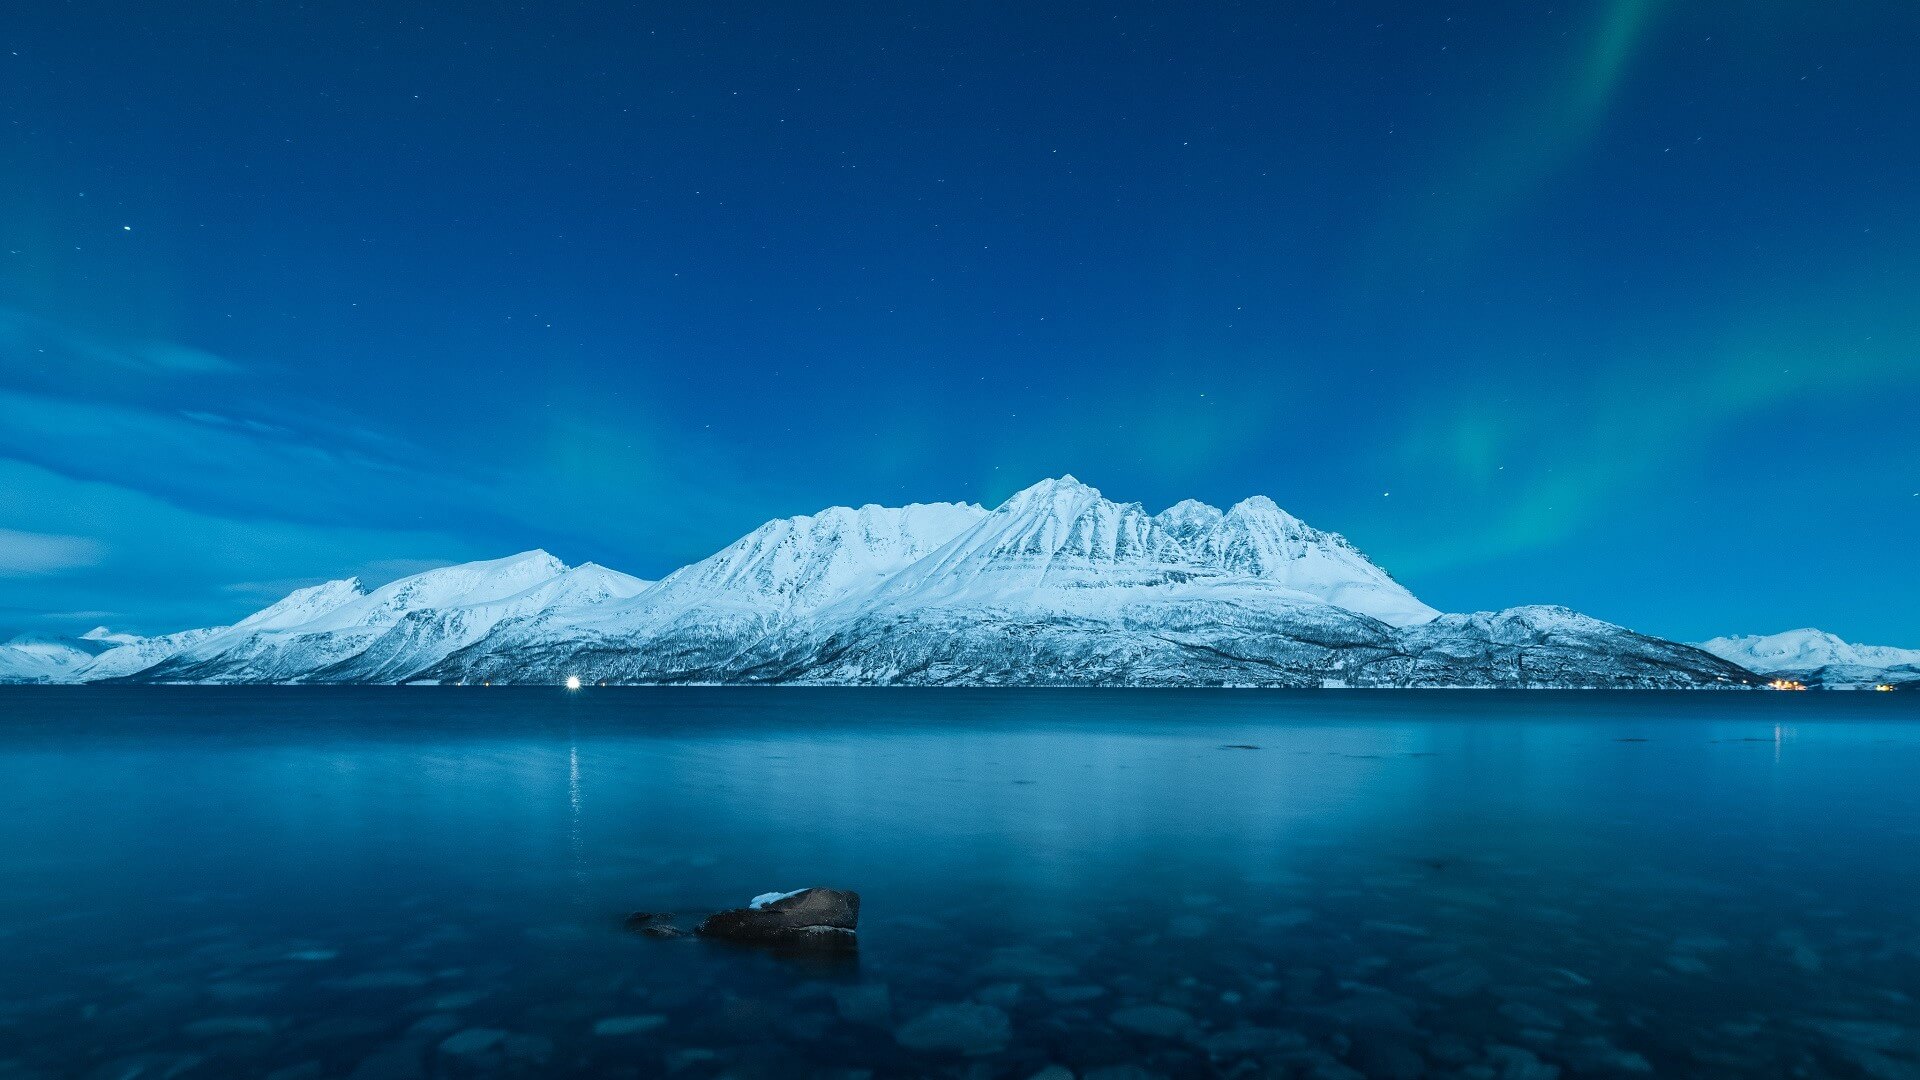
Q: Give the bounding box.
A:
[432,477,1749,686]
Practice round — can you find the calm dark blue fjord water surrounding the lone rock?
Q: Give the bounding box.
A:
[0,688,1920,1080]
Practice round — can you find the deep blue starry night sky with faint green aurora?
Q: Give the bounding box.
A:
[0,0,1920,646]
